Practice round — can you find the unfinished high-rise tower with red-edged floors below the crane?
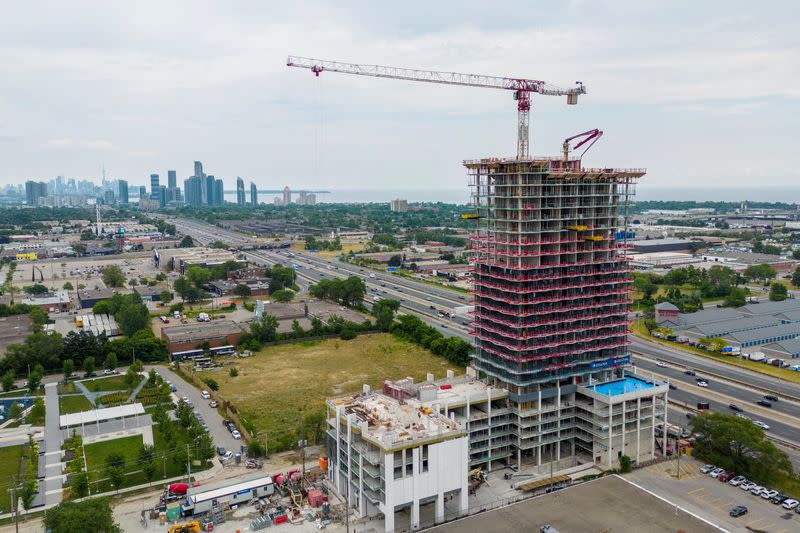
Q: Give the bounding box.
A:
[464,158,644,465]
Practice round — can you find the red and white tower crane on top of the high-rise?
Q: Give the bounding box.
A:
[286,56,586,159]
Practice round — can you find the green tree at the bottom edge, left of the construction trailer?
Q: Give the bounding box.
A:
[43,498,123,533]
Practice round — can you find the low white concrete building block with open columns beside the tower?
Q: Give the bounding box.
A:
[327,385,469,532]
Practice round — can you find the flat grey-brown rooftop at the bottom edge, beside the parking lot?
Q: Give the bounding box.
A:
[435,476,721,533]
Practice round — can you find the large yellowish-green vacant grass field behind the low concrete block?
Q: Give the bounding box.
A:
[199,333,452,448]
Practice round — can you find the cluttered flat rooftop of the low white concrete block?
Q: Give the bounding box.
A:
[328,392,465,449]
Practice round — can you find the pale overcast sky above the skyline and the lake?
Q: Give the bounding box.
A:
[0,0,800,194]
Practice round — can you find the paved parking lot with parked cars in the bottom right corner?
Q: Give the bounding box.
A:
[626,458,800,533]
